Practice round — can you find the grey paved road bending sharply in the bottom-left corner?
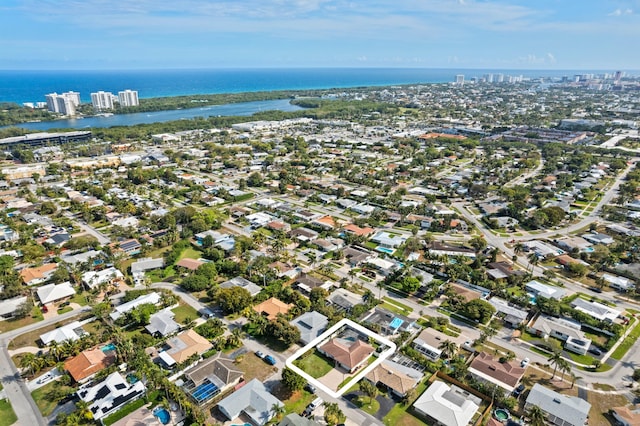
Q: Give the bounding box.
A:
[0,308,90,426]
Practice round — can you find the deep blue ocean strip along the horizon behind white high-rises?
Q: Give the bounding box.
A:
[0,68,593,104]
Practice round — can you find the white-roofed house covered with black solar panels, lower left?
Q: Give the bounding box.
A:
[76,371,146,420]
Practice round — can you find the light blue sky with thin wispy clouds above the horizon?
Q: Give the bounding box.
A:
[0,0,640,70]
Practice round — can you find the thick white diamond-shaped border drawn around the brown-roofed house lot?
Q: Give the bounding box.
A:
[285,318,396,398]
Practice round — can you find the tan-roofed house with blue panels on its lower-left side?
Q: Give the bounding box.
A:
[184,352,244,404]
